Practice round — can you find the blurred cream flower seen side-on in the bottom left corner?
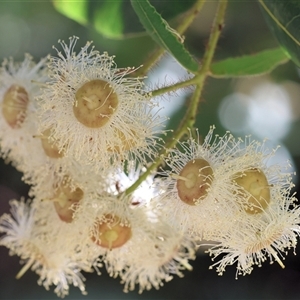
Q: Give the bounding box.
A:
[0,200,99,297]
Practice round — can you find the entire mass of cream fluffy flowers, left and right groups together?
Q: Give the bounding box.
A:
[0,37,300,297]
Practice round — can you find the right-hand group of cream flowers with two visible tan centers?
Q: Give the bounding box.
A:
[155,128,300,275]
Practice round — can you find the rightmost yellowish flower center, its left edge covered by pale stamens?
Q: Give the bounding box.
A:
[233,168,271,214]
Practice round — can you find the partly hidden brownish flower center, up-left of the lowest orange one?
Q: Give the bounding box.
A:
[52,185,84,223]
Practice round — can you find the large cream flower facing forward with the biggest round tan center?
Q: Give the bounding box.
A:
[39,37,164,168]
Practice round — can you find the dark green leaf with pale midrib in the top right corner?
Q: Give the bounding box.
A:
[259,0,300,67]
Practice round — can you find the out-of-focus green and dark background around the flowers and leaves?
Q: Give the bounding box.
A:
[0,0,300,299]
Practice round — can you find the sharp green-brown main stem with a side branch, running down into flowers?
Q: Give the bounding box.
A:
[123,0,227,195]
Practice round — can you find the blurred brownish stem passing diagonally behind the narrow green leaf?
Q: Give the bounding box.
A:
[134,0,205,77]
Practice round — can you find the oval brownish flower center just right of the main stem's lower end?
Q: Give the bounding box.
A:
[177,158,213,205]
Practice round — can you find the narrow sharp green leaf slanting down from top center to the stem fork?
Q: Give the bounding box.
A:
[131,0,198,72]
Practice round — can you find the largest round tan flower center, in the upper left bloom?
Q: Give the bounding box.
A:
[73,79,119,128]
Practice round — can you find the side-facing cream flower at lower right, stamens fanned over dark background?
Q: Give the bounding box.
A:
[207,187,300,275]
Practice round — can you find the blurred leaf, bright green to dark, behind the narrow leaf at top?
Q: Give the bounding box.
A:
[52,0,196,39]
